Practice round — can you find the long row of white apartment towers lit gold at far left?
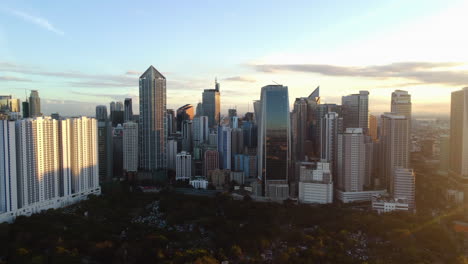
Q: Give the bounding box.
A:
[0,117,100,222]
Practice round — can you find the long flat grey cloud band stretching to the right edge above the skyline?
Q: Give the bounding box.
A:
[252,62,468,86]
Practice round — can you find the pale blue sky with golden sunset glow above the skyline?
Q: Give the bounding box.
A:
[0,0,468,116]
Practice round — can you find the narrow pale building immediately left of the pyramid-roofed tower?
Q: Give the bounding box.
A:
[123,121,138,172]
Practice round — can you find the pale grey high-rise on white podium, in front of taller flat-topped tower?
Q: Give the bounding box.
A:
[337,128,366,192]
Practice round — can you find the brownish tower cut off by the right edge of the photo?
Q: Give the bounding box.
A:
[449,87,468,192]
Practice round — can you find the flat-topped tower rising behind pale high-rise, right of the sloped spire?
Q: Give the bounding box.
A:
[341,91,369,133]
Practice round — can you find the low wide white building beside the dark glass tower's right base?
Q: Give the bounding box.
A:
[299,162,333,204]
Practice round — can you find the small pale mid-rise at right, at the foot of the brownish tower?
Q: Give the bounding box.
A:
[393,167,416,211]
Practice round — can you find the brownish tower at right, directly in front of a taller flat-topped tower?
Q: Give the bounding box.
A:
[380,113,410,194]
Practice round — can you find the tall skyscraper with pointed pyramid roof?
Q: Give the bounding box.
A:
[138,66,167,171]
